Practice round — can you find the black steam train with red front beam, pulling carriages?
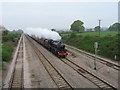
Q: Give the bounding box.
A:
[30,35,68,58]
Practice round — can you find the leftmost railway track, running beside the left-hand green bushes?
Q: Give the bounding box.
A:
[11,37,23,88]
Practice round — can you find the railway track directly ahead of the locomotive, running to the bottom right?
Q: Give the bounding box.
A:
[61,58,117,90]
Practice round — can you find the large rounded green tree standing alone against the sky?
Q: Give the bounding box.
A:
[70,20,85,32]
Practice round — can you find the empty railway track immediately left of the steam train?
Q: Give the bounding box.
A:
[26,36,72,90]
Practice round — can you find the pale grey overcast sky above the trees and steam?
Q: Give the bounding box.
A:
[2,2,118,30]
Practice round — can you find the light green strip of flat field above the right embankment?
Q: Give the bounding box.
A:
[61,31,118,37]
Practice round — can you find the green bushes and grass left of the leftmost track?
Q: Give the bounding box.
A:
[2,30,21,61]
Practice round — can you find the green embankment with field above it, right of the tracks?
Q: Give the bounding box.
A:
[62,32,119,60]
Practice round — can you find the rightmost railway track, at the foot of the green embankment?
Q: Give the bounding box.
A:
[66,45,120,71]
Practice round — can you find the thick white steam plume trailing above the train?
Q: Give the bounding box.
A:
[25,28,61,41]
